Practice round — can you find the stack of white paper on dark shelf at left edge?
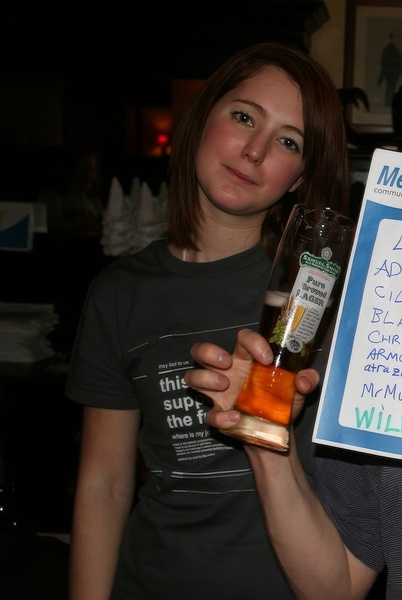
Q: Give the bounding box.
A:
[0,302,59,363]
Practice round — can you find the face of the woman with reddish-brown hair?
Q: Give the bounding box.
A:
[196,66,304,216]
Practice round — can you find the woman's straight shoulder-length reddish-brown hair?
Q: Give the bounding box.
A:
[168,42,349,254]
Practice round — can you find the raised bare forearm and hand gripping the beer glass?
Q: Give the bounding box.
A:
[185,330,377,600]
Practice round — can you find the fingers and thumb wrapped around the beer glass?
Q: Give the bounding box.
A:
[185,329,319,429]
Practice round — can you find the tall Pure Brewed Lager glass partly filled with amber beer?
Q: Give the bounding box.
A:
[223,204,355,451]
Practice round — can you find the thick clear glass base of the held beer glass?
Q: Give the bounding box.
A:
[219,414,289,452]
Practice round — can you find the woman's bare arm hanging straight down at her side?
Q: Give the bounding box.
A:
[69,407,140,600]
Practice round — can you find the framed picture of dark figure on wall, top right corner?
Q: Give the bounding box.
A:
[344,0,402,132]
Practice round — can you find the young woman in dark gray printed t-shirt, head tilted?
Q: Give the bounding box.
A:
[66,43,348,600]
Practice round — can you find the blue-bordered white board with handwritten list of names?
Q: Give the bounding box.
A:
[313,149,402,458]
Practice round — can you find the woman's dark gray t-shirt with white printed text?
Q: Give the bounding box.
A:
[66,241,324,600]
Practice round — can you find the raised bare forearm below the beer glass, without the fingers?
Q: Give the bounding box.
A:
[245,433,377,600]
